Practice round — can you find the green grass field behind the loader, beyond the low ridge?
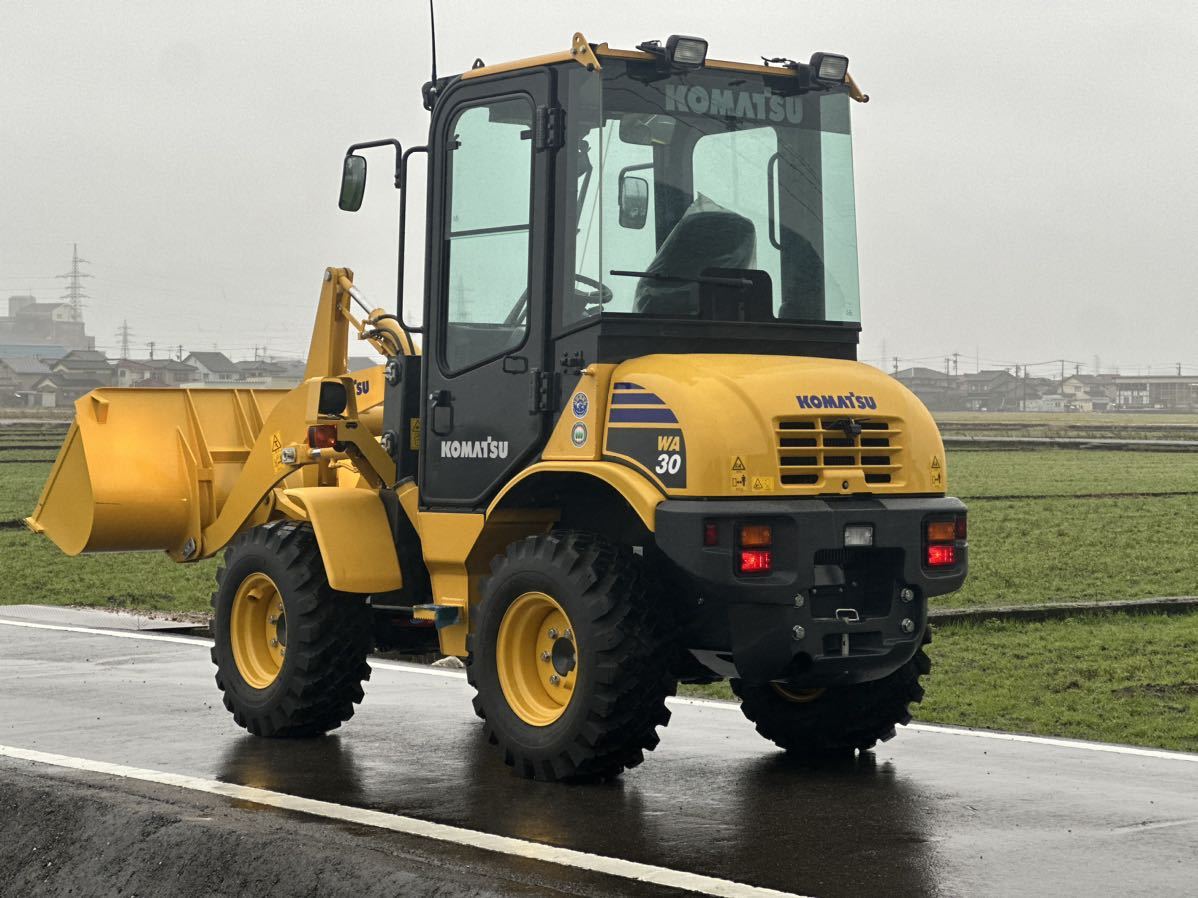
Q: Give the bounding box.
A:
[7,450,1198,609]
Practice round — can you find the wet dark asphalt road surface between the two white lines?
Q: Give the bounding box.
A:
[0,614,1198,898]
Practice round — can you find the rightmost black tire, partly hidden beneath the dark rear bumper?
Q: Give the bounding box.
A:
[731,632,932,760]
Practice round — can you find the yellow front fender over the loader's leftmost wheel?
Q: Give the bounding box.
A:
[283,486,404,593]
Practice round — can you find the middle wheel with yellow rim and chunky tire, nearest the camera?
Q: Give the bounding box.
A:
[466,532,676,781]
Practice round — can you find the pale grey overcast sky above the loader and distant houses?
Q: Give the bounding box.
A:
[0,0,1198,374]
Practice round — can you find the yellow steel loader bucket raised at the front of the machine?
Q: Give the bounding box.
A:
[25,388,288,559]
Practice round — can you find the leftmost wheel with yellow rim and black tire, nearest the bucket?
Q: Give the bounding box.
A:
[212,522,371,738]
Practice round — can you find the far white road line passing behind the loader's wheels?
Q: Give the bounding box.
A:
[0,618,1198,764]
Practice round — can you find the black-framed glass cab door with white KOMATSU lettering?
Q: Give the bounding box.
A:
[419,69,559,508]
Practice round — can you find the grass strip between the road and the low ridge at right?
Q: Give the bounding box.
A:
[679,614,1198,752]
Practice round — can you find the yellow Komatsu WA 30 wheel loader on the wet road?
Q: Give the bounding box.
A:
[29,35,967,779]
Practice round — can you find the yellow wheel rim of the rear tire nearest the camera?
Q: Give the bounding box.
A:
[495,593,579,727]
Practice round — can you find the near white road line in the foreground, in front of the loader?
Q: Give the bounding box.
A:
[0,745,814,898]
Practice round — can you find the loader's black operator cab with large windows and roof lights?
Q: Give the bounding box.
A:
[343,35,866,509]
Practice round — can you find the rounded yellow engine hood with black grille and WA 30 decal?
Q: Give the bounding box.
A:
[603,354,948,498]
